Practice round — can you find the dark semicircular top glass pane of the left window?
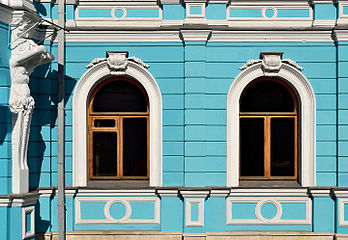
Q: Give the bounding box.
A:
[93,80,147,112]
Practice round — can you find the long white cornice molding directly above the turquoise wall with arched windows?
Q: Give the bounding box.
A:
[40,30,334,43]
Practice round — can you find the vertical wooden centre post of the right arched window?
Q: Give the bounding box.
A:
[264,116,271,179]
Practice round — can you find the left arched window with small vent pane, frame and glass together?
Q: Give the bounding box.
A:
[88,76,149,180]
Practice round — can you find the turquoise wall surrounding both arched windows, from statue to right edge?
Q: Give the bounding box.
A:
[28,42,342,189]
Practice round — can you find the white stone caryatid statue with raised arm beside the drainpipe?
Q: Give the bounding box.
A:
[9,16,54,193]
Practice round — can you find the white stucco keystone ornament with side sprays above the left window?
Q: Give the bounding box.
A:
[86,52,150,75]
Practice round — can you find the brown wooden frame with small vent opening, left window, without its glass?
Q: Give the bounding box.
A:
[88,77,150,180]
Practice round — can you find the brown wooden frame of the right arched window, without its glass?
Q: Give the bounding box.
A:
[239,77,299,180]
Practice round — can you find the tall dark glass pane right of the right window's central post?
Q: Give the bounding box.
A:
[271,118,295,176]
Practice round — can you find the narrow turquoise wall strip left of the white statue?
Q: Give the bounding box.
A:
[0,22,12,194]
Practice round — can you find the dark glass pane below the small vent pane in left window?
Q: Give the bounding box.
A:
[93,132,117,176]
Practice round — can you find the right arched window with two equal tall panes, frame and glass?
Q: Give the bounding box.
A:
[239,77,298,179]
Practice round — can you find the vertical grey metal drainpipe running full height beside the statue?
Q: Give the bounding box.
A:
[57,0,65,240]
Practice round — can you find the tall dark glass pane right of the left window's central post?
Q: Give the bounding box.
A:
[123,118,147,176]
